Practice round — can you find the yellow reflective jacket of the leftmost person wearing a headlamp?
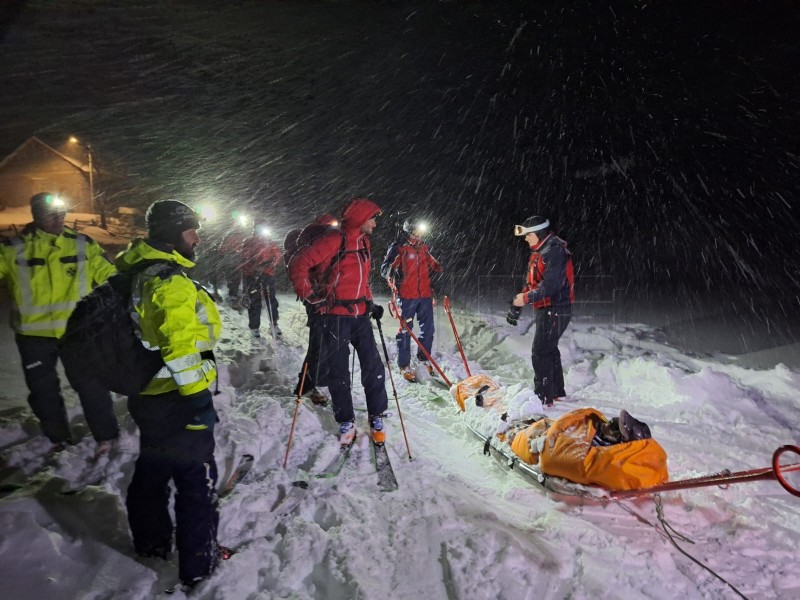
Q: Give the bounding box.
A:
[0,223,115,338]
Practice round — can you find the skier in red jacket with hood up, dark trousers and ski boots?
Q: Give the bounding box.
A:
[289,198,388,446]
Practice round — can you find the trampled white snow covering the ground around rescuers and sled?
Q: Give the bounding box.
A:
[0,294,800,600]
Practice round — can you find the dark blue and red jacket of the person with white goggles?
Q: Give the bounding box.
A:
[522,233,575,310]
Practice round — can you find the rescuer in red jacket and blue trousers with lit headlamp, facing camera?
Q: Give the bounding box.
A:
[381,219,442,381]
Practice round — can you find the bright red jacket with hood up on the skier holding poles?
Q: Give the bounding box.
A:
[289,198,380,317]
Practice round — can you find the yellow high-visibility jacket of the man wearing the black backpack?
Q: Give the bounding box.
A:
[115,239,222,396]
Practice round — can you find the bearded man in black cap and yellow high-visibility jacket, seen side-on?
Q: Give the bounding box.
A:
[115,200,222,587]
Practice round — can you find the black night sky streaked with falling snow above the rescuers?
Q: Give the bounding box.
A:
[0,0,800,312]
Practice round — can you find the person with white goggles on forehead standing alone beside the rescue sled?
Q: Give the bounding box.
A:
[506,216,575,406]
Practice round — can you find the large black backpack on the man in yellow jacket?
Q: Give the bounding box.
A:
[58,261,180,396]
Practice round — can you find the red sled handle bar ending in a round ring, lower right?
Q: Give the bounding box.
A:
[610,445,800,498]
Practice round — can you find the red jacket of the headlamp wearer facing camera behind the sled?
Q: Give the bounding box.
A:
[381,237,442,299]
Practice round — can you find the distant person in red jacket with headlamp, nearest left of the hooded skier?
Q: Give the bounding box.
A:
[239,219,283,338]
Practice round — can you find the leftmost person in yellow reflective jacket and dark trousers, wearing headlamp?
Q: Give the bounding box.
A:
[0,193,119,453]
